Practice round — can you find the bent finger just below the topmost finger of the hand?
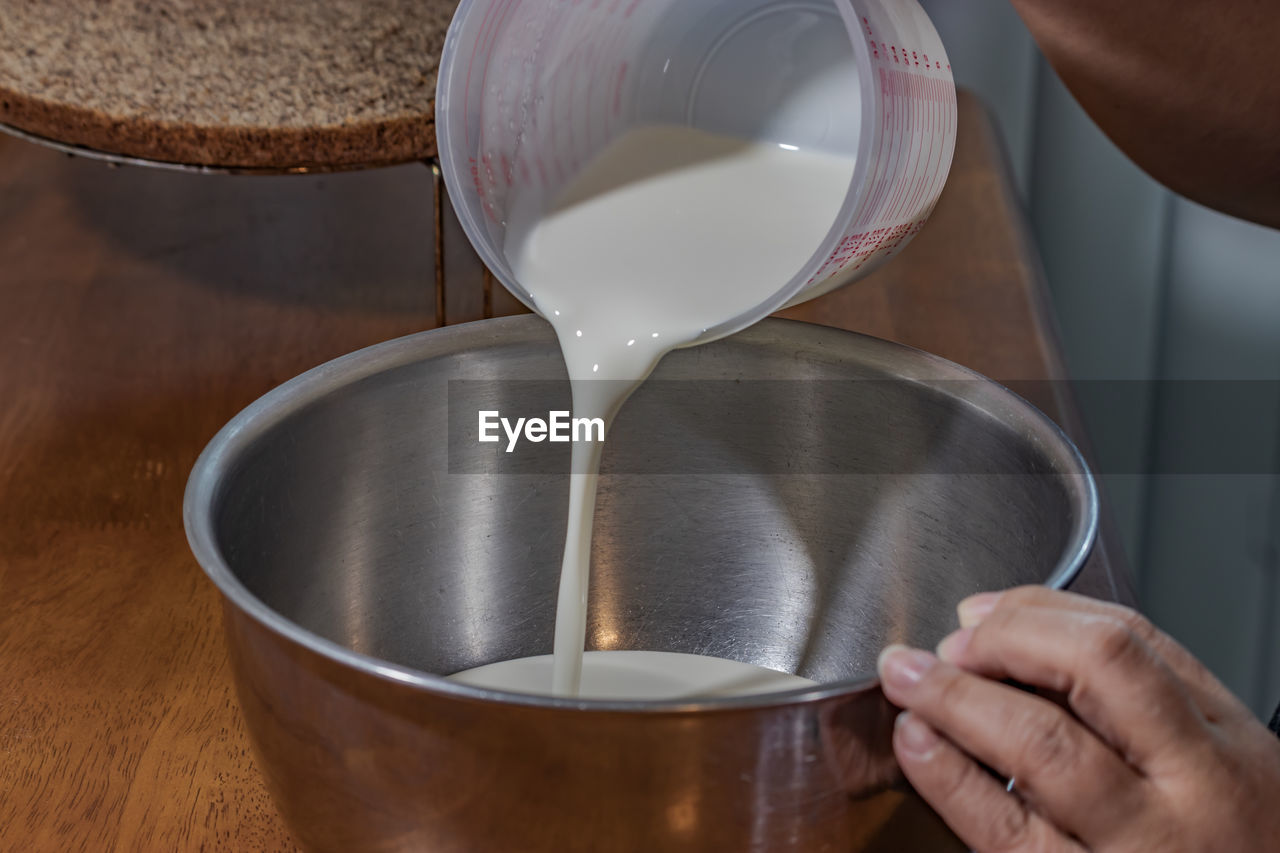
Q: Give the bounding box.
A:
[938,607,1208,770]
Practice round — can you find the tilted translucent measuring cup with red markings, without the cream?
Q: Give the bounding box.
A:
[435,0,956,343]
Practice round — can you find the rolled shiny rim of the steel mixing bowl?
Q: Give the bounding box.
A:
[183,315,1101,713]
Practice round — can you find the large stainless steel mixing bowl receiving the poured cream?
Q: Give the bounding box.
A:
[186,316,1097,853]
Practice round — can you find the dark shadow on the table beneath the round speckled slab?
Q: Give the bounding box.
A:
[51,142,435,315]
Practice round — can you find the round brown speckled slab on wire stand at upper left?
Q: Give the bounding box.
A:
[0,0,458,169]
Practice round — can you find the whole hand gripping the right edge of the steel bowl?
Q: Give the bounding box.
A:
[879,588,1280,853]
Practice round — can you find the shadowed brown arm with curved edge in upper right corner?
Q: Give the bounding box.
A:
[1011,0,1280,228]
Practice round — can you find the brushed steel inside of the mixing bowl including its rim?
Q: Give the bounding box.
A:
[186,316,1098,711]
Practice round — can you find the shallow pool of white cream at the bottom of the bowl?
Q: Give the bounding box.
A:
[449,652,817,699]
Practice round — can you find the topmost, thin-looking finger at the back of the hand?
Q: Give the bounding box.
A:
[957,587,1249,722]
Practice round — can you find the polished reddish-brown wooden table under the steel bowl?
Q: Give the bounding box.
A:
[0,97,1130,852]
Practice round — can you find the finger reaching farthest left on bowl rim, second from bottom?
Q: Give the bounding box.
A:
[881,647,1146,844]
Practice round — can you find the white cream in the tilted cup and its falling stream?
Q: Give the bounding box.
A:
[504,127,854,695]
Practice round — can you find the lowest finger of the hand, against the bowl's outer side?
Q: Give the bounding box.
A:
[893,711,1082,853]
